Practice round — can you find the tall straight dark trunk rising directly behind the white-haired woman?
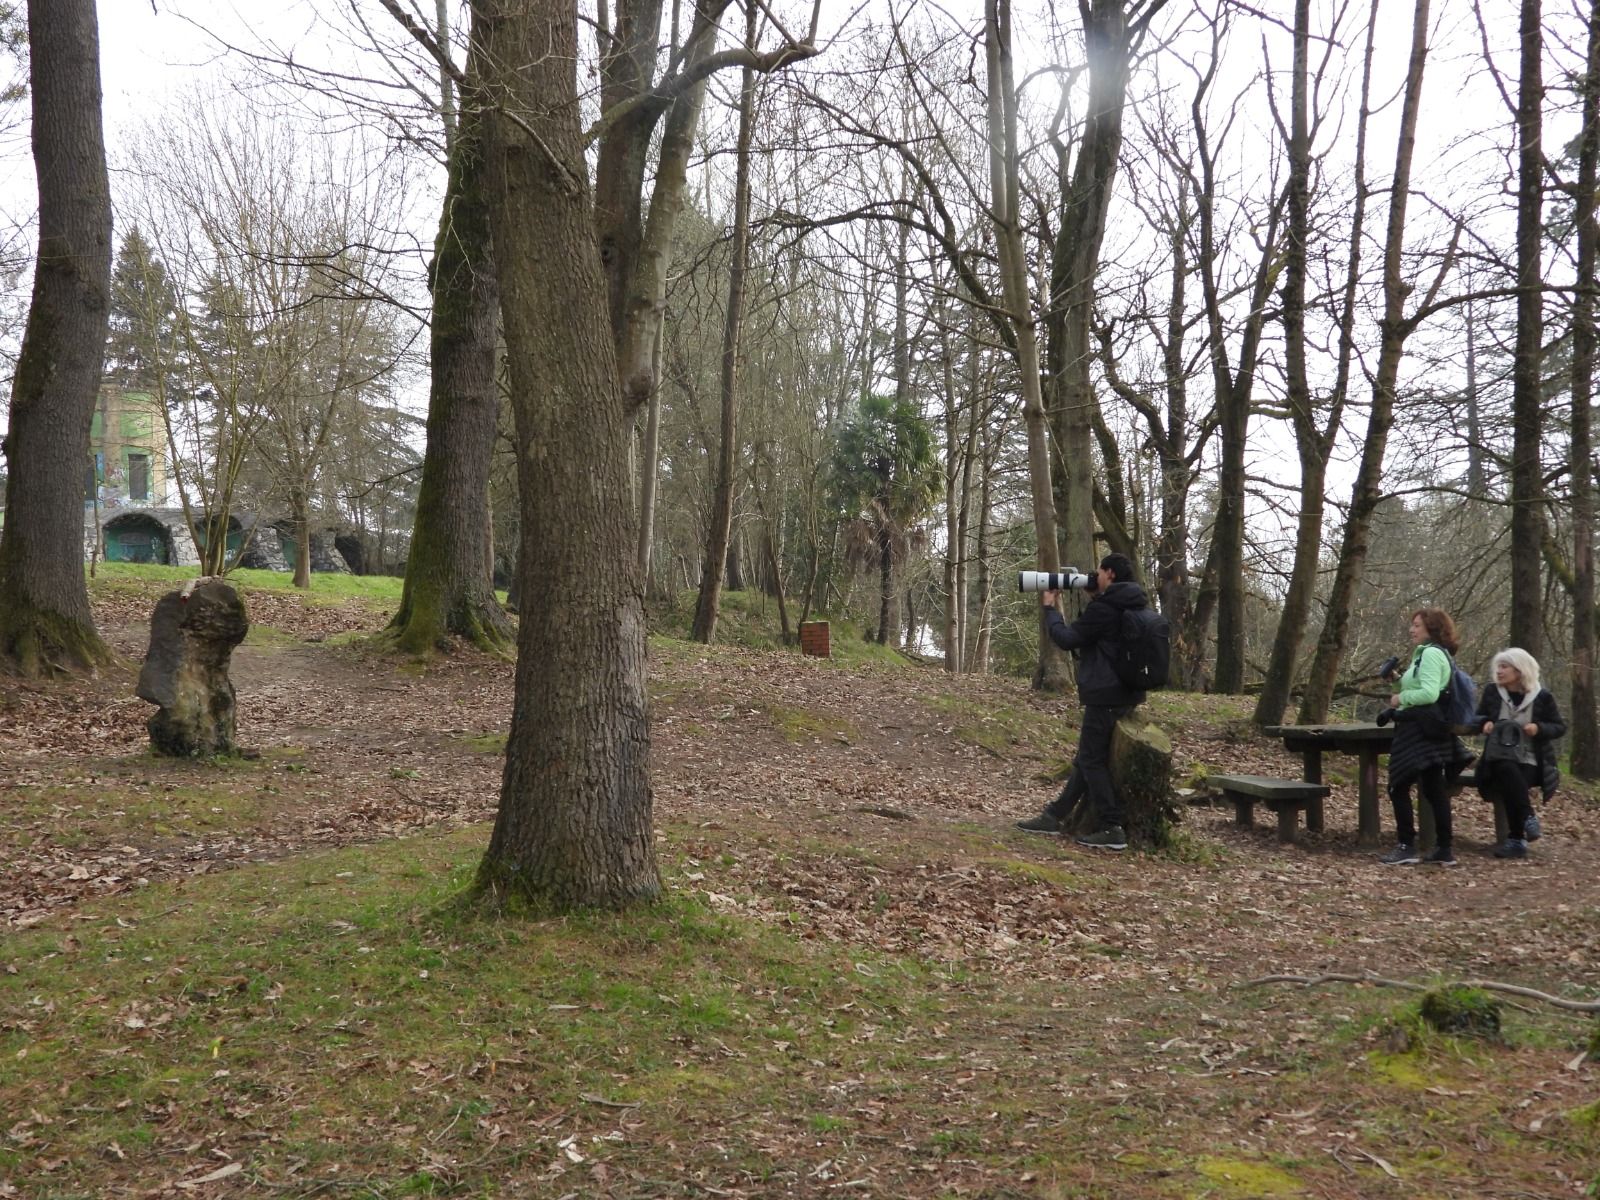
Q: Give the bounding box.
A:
[1510,0,1544,659]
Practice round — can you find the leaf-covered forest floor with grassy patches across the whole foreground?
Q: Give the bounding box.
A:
[0,576,1600,1200]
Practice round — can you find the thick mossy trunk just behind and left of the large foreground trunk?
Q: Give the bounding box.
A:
[390,92,512,654]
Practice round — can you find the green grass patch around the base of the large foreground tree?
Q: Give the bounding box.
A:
[0,830,960,1197]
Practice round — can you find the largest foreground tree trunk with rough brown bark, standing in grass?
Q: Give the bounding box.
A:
[472,0,661,909]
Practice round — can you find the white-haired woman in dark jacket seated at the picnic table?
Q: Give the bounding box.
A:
[1478,646,1566,858]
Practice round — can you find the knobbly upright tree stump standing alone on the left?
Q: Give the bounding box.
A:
[138,579,250,758]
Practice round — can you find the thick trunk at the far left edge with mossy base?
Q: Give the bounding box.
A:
[0,0,110,675]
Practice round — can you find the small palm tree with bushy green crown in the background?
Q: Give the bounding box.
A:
[830,395,941,645]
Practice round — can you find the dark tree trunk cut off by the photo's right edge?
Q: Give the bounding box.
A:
[1568,0,1600,779]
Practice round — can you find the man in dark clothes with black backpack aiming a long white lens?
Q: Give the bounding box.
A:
[1016,554,1150,850]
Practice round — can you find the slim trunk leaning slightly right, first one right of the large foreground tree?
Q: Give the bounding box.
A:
[690,37,755,642]
